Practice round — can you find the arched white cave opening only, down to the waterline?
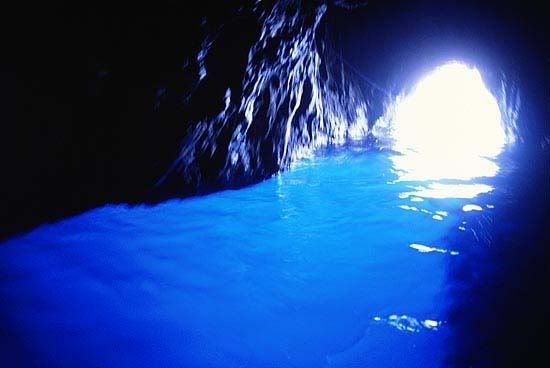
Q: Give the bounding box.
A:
[392,63,506,157]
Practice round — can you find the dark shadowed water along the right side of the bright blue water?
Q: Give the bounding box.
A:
[447,152,550,367]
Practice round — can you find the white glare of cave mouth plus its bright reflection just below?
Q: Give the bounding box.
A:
[384,63,506,184]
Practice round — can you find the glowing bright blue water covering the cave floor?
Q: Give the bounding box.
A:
[0,149,508,368]
